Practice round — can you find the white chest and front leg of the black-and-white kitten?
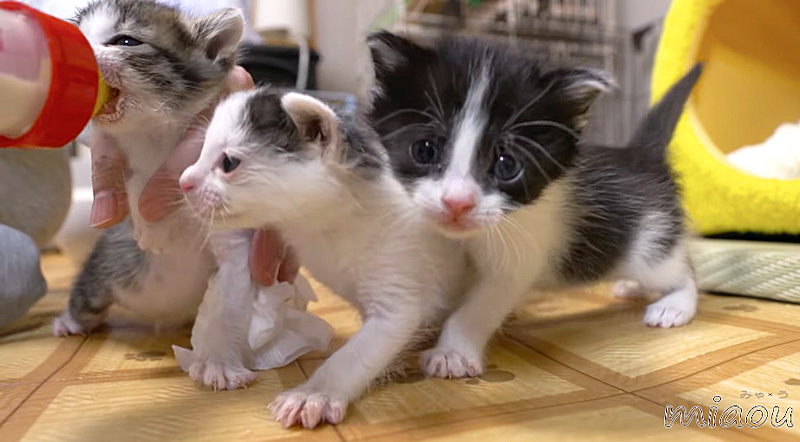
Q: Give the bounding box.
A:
[422,178,569,377]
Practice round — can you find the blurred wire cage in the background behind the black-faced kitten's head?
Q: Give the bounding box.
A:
[393,0,660,144]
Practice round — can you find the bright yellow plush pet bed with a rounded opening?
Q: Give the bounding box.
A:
[652,0,800,235]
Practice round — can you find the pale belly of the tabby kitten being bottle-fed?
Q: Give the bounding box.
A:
[115,247,215,324]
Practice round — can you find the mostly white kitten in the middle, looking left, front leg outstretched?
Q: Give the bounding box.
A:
[181,89,468,428]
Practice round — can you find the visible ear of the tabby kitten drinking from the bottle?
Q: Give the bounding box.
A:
[195,8,244,61]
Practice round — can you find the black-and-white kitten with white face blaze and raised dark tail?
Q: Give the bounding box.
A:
[368,32,700,377]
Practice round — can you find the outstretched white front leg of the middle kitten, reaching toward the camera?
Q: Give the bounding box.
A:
[270,294,424,428]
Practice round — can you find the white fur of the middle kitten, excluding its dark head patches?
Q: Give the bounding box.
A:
[184,93,465,428]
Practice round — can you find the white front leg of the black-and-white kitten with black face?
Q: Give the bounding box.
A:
[422,276,527,378]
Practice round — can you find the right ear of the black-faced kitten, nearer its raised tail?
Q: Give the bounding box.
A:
[541,69,616,129]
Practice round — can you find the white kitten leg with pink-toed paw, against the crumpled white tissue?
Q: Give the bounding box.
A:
[173,231,258,390]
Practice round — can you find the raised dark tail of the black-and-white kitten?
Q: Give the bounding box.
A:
[628,63,703,160]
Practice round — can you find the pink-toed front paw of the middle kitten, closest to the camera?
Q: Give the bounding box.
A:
[269,391,347,429]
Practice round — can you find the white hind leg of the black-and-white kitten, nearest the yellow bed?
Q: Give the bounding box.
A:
[636,247,698,328]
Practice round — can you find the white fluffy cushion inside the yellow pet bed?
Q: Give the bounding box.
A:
[728,119,800,180]
